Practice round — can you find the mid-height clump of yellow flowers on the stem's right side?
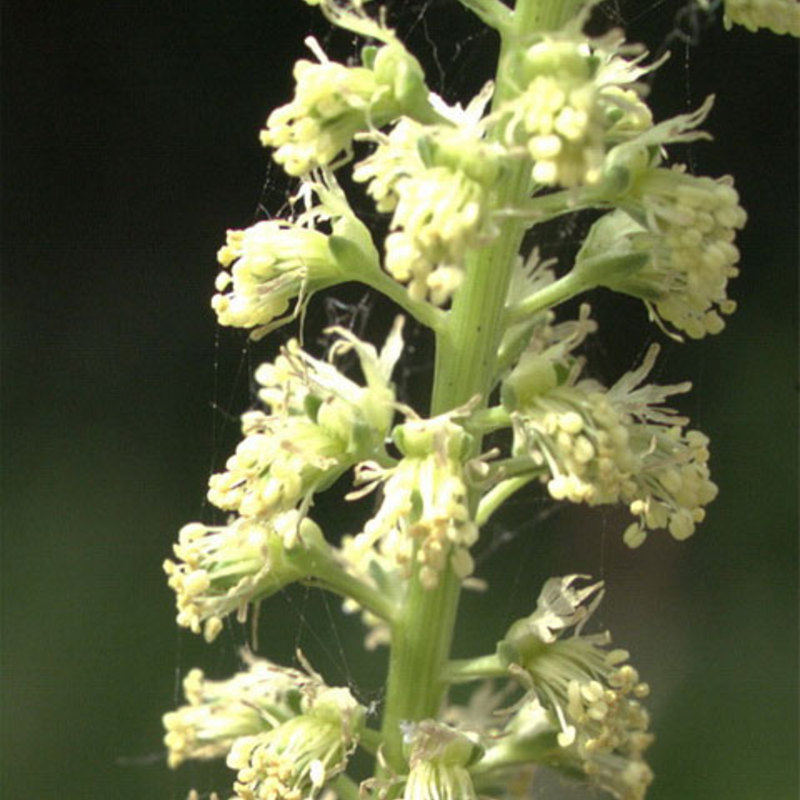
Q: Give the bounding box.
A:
[505,328,717,547]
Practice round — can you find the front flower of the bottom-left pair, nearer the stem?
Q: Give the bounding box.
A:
[227,685,366,800]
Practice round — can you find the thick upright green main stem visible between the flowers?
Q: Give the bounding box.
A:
[378,0,579,780]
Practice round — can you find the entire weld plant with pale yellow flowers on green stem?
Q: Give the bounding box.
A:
[159,0,800,800]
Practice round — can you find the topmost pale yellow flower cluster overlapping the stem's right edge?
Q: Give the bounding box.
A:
[498,31,652,188]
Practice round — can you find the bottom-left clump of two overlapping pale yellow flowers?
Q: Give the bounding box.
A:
[164,652,366,800]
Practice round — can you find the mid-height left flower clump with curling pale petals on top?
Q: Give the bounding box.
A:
[208,318,402,518]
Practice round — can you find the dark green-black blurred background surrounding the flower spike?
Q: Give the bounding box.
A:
[0,0,798,800]
